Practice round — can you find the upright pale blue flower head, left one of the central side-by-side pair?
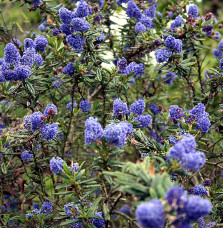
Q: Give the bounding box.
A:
[84,117,103,143]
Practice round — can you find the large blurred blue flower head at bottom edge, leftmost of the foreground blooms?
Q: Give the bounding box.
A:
[136,199,165,228]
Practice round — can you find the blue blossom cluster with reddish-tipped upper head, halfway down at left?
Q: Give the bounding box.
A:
[23,104,58,140]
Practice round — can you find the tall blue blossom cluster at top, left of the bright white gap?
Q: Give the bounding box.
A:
[59,0,91,52]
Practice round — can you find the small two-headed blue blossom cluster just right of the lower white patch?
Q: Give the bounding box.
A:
[117,57,145,78]
